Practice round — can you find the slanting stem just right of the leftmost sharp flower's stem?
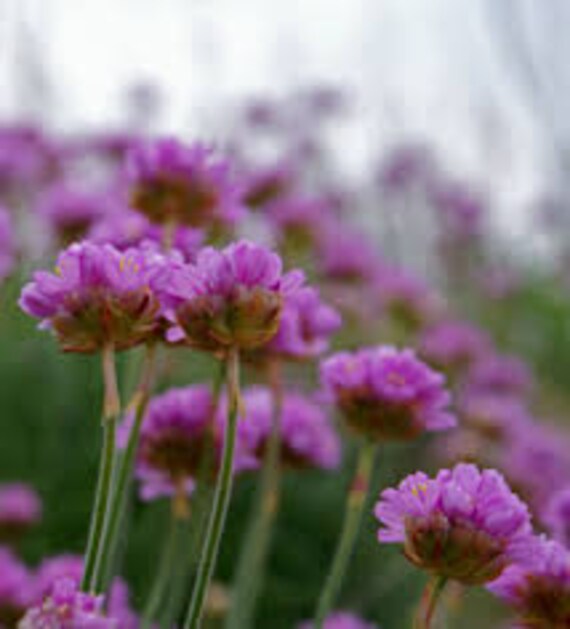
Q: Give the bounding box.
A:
[93,344,156,592]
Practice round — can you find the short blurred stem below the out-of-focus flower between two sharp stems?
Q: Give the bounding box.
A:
[141,508,187,629]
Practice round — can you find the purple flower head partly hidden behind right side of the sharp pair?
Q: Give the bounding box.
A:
[266,287,342,360]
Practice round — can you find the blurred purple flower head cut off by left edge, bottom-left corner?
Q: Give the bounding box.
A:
[0,547,33,627]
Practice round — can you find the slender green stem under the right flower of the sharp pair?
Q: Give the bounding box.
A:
[182,348,240,629]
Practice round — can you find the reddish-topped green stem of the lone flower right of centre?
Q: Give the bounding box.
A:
[315,441,376,629]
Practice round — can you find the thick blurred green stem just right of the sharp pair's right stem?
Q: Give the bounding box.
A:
[225,360,283,629]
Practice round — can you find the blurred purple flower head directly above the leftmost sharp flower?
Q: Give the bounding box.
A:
[38,183,110,245]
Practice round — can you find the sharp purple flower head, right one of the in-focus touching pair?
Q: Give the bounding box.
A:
[165,241,304,352]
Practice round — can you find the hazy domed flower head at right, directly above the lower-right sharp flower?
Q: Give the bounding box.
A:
[465,353,533,396]
